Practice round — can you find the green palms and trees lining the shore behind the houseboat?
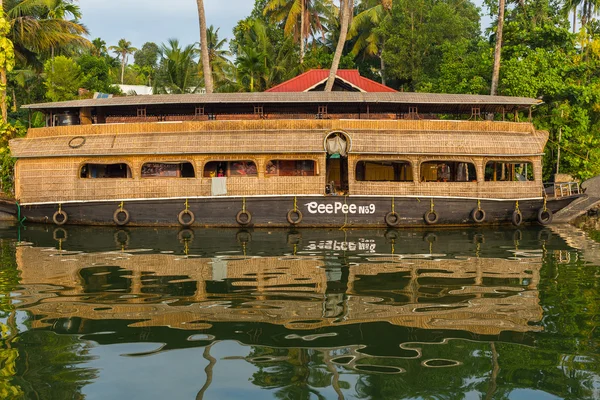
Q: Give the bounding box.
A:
[0,0,600,193]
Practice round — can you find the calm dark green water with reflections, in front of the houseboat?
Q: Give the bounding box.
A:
[0,226,600,399]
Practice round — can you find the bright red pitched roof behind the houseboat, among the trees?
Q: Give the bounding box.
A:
[266,69,396,93]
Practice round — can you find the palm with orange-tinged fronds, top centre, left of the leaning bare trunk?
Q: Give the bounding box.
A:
[263,0,333,63]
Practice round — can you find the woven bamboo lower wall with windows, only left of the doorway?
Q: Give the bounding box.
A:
[15,154,325,203]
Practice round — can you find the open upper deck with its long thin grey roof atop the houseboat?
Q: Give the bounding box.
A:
[23,92,541,126]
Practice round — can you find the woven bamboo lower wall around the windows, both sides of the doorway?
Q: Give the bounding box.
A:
[15,154,542,203]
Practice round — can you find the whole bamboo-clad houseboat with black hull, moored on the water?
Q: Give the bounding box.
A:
[5,92,579,228]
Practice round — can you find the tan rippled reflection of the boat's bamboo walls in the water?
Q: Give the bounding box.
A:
[17,246,542,335]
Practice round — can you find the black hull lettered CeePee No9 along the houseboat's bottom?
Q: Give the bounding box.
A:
[21,196,578,228]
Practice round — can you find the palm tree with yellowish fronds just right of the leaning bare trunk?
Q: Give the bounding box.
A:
[348,0,392,85]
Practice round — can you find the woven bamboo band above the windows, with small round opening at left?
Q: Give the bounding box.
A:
[10,130,547,158]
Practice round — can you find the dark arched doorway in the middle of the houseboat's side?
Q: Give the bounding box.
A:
[325,132,349,195]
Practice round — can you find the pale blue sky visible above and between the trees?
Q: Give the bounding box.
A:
[79,0,489,52]
